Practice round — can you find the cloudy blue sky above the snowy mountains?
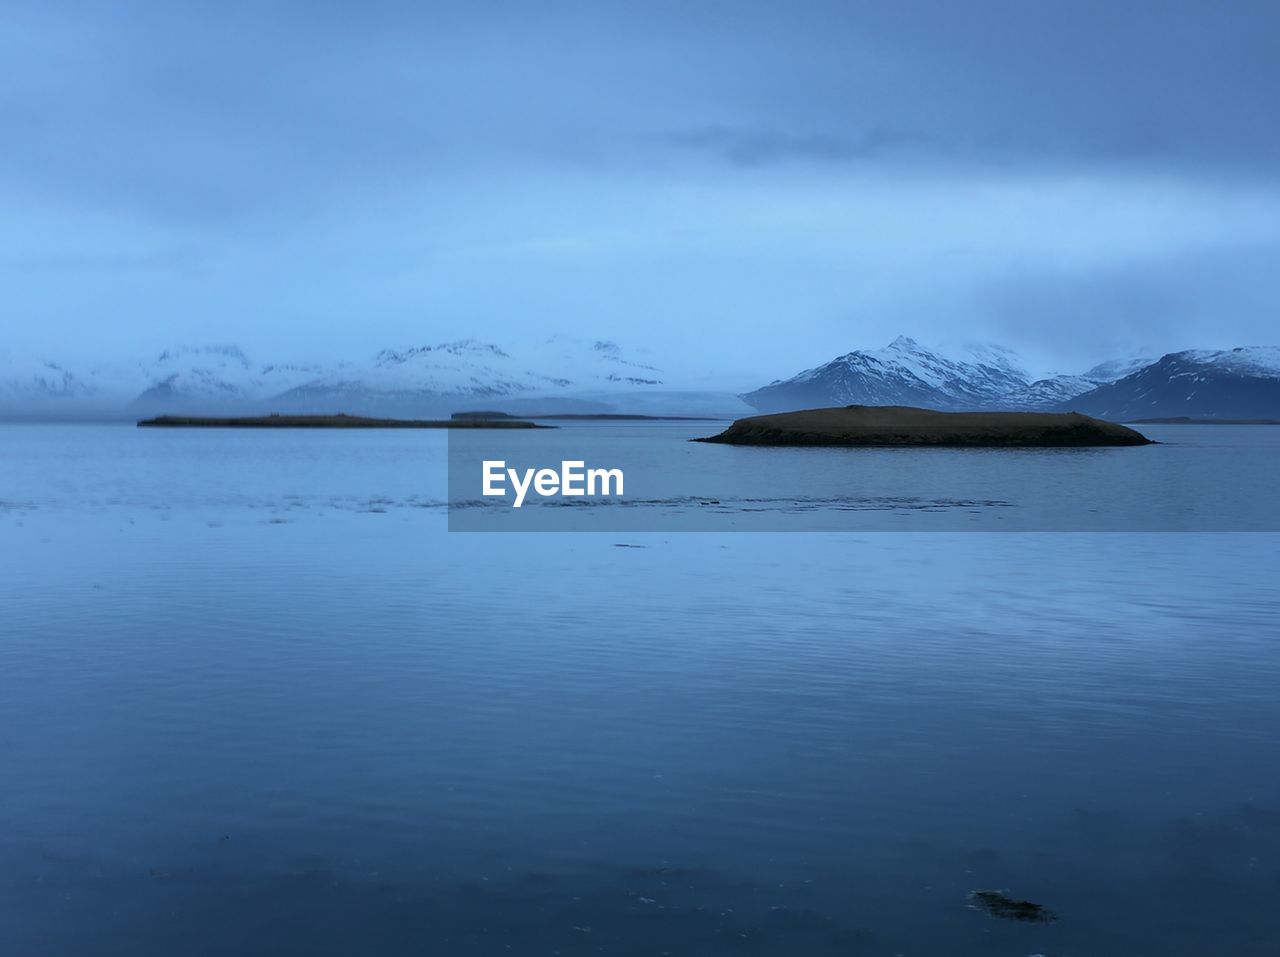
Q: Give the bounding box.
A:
[0,0,1280,386]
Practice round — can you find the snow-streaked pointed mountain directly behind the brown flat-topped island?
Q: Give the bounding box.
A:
[742,335,1030,412]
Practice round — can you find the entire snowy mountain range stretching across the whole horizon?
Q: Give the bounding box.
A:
[0,336,1280,421]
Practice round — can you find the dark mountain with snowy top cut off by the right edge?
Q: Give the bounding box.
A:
[1061,345,1280,421]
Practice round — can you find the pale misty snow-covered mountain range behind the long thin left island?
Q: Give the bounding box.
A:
[0,336,750,418]
